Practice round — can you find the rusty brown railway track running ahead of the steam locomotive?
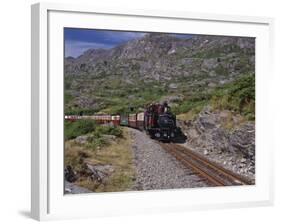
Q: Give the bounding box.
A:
[159,143,253,186]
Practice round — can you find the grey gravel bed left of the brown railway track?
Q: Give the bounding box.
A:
[130,129,208,190]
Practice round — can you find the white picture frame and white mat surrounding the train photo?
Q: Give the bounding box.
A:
[31,3,274,220]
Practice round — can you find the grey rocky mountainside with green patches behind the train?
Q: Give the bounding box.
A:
[65,33,255,113]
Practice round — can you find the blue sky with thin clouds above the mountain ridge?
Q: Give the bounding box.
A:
[64,28,191,57]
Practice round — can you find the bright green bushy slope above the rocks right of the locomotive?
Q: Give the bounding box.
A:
[172,74,255,120]
